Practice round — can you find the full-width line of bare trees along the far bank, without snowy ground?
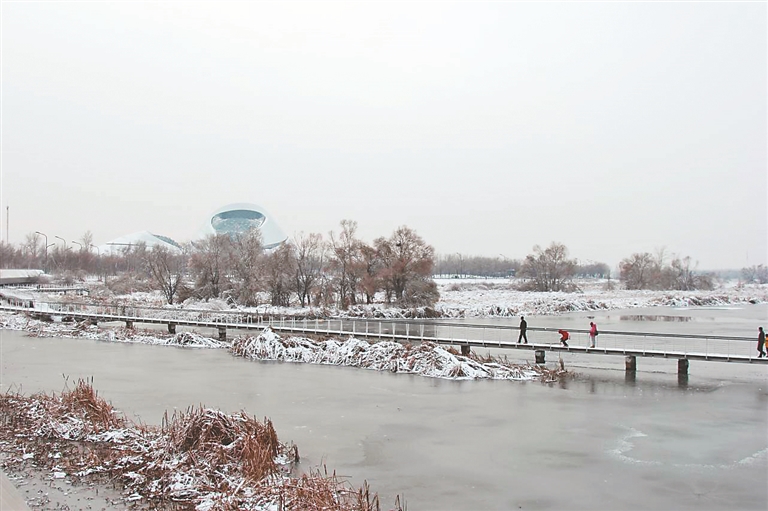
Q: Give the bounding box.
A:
[0,226,768,309]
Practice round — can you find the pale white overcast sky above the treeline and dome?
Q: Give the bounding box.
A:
[1,2,768,269]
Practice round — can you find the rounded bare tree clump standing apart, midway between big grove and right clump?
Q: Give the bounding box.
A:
[520,242,576,291]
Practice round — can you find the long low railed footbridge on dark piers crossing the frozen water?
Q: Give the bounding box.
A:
[0,301,768,374]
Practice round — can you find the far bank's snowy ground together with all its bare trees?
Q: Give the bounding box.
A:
[0,229,766,318]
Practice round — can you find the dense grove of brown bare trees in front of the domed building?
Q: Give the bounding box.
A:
[0,220,439,309]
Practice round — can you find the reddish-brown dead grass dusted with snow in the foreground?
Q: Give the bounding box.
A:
[0,380,403,511]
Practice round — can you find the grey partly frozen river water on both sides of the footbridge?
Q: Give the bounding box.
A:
[0,305,768,511]
